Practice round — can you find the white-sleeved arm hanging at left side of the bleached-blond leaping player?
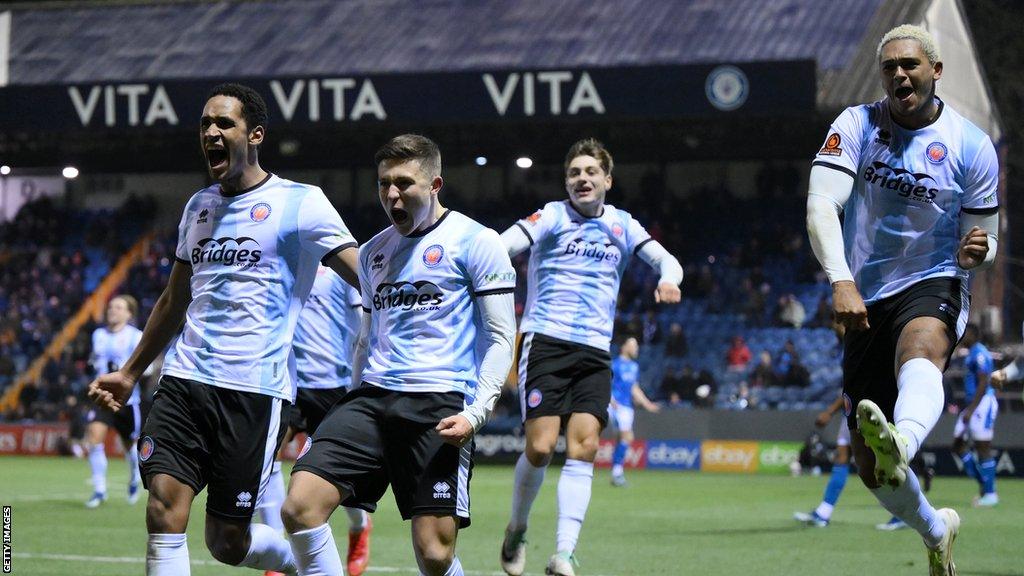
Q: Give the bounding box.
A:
[807,164,868,330]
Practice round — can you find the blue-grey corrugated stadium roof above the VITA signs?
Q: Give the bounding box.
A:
[9,0,884,84]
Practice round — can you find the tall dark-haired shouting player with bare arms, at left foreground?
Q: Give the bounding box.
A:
[89,84,358,576]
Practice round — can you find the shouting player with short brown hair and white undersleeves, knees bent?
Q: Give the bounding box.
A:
[282,134,515,576]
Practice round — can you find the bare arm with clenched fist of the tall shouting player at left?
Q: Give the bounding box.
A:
[89,261,191,410]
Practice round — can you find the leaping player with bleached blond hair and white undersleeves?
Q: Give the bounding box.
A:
[807,25,998,576]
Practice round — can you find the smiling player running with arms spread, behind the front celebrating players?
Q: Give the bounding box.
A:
[501,138,683,576]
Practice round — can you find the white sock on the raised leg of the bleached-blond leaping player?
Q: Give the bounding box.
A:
[893,358,945,459]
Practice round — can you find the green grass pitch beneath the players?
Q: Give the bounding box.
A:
[0,457,1024,576]
